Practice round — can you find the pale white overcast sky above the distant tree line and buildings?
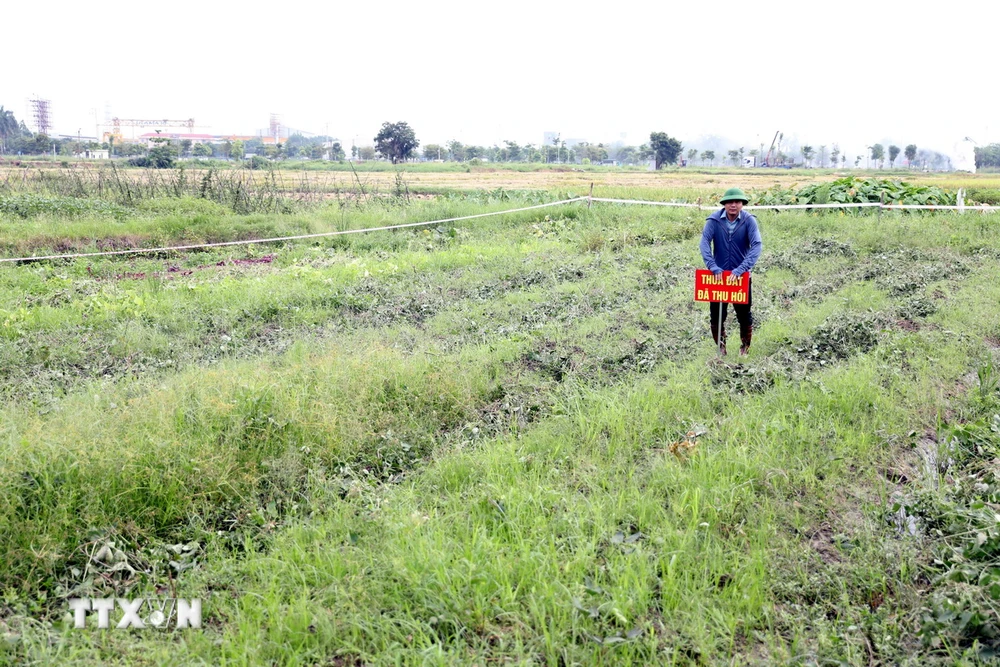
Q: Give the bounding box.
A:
[0,0,1000,162]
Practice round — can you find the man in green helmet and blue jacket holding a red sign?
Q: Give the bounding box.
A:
[701,188,764,355]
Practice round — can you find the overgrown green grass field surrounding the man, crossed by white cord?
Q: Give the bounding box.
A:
[0,173,1000,665]
